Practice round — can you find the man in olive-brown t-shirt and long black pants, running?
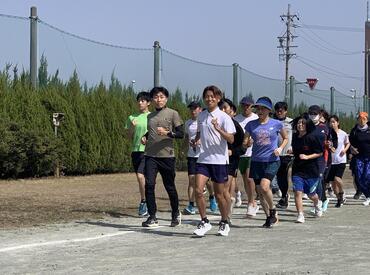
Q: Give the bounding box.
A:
[142,87,184,227]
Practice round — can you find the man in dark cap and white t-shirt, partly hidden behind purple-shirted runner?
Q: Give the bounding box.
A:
[234,96,259,217]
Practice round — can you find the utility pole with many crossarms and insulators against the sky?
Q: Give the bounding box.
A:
[278,4,299,102]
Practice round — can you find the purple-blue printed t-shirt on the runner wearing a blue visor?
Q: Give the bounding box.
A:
[245,118,283,162]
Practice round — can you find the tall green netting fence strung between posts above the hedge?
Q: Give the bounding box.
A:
[0,11,363,115]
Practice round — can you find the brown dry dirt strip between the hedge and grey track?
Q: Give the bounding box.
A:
[0,170,352,229]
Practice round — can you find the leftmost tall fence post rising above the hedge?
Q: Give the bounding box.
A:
[30,7,38,88]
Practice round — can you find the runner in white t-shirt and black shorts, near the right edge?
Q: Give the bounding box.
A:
[328,115,351,207]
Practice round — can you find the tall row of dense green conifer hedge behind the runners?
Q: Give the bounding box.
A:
[0,57,354,178]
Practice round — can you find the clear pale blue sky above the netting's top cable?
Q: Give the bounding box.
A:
[0,0,366,98]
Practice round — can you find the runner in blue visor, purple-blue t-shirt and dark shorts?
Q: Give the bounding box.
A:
[245,97,288,228]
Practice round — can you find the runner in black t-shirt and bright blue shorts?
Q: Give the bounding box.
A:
[292,115,323,223]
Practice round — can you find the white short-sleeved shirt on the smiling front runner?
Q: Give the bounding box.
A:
[197,108,236,164]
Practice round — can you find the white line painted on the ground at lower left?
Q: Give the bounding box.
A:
[0,231,135,252]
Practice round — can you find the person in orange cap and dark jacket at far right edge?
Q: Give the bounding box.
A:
[349,112,370,206]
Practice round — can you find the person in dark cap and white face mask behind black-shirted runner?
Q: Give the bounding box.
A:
[308,105,338,212]
